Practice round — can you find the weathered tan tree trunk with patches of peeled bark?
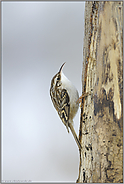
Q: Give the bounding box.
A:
[77,1,123,183]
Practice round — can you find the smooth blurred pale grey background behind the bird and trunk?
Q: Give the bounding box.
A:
[1,1,85,182]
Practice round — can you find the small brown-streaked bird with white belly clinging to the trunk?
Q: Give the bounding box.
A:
[50,62,82,150]
